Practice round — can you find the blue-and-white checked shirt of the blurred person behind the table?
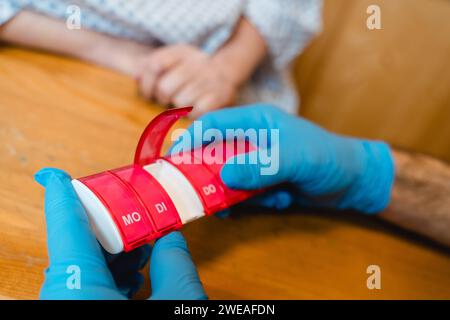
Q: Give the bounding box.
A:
[0,0,322,113]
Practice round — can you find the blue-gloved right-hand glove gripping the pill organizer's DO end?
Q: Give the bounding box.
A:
[171,104,394,214]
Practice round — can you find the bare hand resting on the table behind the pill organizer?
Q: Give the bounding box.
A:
[138,45,237,117]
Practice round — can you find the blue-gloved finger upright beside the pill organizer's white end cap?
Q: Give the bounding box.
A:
[35,168,106,267]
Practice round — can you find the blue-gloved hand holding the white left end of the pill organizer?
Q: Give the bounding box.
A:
[35,169,207,299]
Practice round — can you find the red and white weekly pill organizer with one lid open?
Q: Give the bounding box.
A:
[72,107,259,253]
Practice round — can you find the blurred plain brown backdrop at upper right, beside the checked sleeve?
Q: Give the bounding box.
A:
[295,0,450,161]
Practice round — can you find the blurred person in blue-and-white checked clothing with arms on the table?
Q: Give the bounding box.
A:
[0,0,322,117]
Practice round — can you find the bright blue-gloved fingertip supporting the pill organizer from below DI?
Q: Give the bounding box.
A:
[150,231,207,300]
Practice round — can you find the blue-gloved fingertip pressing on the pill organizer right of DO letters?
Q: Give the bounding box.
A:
[220,151,289,190]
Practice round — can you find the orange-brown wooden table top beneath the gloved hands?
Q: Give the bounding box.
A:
[0,48,450,299]
